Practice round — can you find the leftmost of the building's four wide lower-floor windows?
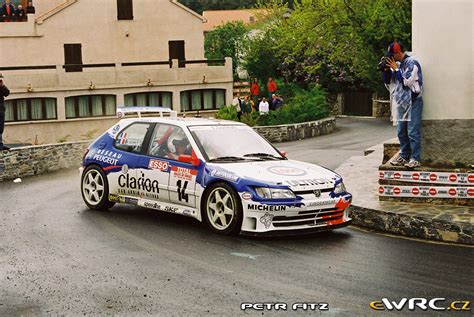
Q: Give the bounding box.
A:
[5,98,57,122]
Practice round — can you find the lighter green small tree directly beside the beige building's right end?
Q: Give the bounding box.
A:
[204,21,248,75]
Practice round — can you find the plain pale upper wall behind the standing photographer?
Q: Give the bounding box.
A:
[412,0,474,120]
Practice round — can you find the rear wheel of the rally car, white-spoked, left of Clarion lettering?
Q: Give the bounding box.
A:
[81,165,115,210]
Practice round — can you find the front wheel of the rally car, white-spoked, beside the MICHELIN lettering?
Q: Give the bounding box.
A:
[201,182,243,234]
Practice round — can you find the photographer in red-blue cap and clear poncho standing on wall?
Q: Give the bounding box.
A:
[379,42,423,168]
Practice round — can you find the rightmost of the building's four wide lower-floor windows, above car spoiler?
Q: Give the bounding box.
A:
[181,89,225,111]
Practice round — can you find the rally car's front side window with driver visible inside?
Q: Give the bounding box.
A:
[148,124,192,161]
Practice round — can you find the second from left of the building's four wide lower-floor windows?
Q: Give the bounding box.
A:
[66,95,117,119]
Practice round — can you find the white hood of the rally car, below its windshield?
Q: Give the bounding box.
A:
[208,160,341,191]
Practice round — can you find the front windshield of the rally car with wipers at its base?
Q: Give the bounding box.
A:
[189,125,285,162]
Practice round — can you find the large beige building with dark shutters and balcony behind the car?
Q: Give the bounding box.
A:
[0,0,233,143]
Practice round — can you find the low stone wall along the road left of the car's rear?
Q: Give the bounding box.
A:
[0,141,91,181]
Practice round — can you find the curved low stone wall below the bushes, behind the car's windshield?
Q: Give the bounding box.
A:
[254,117,336,143]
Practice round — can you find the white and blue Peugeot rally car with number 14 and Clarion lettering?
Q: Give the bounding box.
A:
[81,107,352,235]
